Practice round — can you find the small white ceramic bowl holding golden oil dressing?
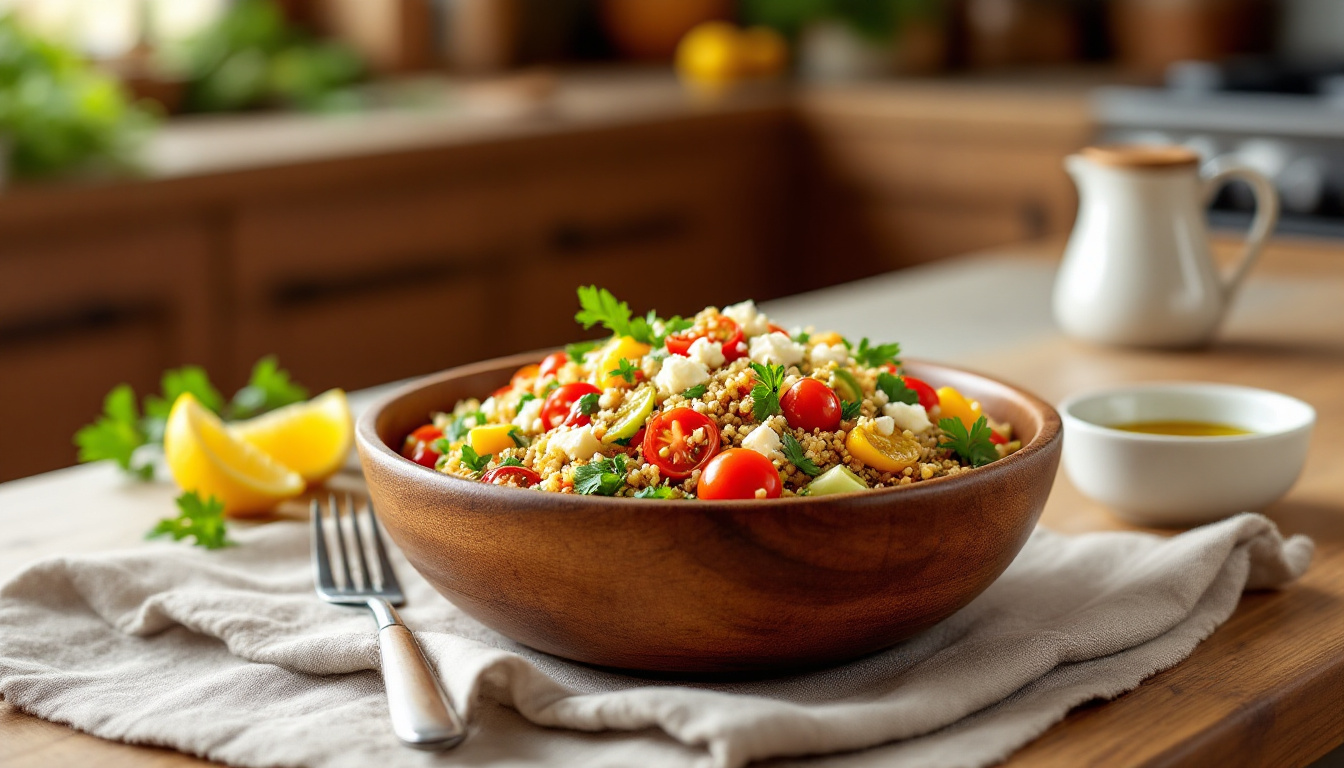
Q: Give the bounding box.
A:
[1059,383,1316,526]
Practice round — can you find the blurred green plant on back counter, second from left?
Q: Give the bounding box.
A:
[164,0,364,112]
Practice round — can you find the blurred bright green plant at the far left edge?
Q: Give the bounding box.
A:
[0,15,155,178]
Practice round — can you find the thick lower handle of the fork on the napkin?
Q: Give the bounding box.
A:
[378,623,466,749]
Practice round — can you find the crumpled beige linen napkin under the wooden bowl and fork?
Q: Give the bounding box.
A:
[0,514,1312,768]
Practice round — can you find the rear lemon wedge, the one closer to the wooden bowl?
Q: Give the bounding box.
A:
[228,389,354,483]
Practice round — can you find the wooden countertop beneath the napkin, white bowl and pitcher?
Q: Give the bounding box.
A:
[0,238,1344,768]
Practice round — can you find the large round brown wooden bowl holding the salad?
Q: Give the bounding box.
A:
[356,354,1060,674]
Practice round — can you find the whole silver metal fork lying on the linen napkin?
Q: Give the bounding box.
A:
[313,494,466,749]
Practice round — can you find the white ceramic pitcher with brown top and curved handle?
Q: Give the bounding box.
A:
[1055,147,1278,347]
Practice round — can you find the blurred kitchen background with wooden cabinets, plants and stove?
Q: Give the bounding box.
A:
[0,0,1344,480]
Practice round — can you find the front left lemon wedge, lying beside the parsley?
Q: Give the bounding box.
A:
[164,394,304,515]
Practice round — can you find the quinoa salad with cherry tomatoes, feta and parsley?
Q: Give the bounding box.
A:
[402,286,1020,499]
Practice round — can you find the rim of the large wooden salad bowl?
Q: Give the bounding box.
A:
[355,347,1064,510]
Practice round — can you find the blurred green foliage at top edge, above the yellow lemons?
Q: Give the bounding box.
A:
[741,0,942,43]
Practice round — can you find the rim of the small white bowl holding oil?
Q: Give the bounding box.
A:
[1056,381,1316,445]
